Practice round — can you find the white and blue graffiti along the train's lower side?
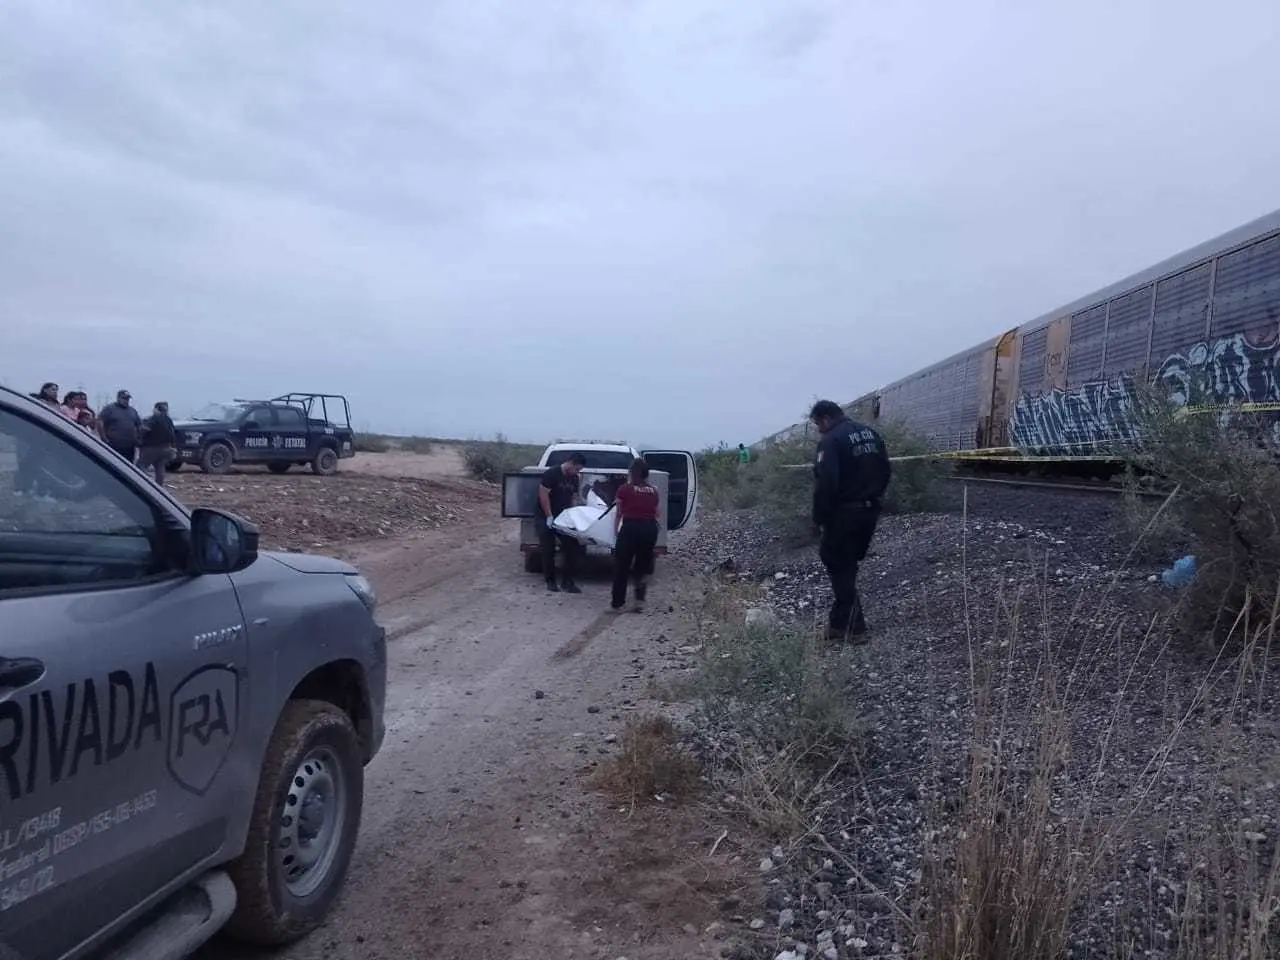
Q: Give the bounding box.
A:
[1009,334,1280,454]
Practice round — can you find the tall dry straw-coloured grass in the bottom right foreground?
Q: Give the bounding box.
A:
[910,488,1280,960]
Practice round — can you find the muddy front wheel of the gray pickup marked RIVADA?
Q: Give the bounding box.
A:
[227,700,365,946]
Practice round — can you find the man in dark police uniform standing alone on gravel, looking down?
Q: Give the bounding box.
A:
[809,401,891,643]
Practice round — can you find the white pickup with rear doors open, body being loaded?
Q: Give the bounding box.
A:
[502,440,698,573]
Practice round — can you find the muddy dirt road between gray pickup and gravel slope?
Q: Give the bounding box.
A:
[200,509,740,960]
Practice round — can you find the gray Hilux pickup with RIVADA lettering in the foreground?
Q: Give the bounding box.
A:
[0,388,387,960]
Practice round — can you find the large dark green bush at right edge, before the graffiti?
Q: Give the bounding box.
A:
[1128,389,1280,637]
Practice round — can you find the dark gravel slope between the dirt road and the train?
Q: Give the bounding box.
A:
[682,485,1280,957]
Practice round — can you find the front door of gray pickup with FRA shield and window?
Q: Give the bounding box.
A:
[0,407,248,957]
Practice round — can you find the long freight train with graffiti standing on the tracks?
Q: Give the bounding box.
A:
[771,211,1280,457]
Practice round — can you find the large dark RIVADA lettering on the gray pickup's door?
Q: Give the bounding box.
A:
[0,663,164,801]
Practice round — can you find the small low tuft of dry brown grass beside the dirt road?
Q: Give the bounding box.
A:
[593,714,700,805]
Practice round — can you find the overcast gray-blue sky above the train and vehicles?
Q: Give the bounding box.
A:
[0,0,1280,447]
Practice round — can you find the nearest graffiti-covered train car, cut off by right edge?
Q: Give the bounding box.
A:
[1007,211,1280,457]
